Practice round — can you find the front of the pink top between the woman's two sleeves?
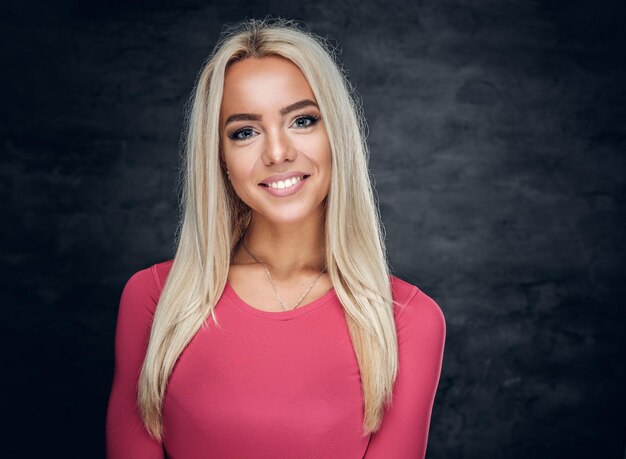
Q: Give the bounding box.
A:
[164,304,368,457]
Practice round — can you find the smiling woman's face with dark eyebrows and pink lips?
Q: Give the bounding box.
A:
[220,56,331,223]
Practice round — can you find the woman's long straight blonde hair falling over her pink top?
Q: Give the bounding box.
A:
[138,18,398,440]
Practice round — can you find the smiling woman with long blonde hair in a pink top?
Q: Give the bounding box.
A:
[106,20,446,459]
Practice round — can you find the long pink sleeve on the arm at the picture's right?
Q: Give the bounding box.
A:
[364,287,446,459]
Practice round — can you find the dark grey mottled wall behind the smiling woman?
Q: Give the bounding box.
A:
[0,0,626,459]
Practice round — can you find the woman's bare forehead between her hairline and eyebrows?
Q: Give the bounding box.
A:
[220,56,317,117]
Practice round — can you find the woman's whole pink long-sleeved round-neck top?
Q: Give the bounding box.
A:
[106,260,446,459]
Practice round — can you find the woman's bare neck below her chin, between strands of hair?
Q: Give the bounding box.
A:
[234,207,326,279]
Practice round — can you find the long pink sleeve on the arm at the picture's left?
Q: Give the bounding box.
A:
[106,268,164,459]
